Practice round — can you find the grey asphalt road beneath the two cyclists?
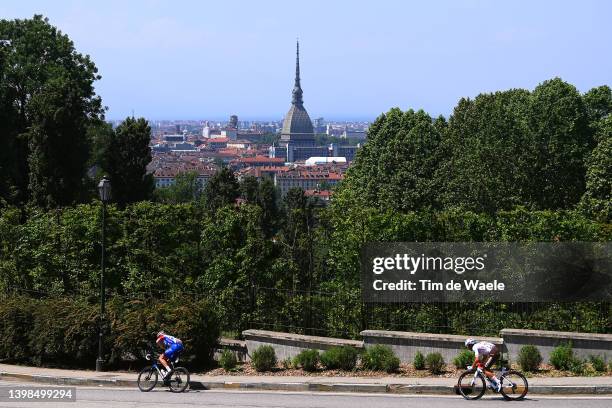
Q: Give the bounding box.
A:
[0,381,612,408]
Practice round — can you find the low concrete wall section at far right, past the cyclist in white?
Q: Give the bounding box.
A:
[501,329,612,363]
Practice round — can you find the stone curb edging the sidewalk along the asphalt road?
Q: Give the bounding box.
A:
[0,372,612,395]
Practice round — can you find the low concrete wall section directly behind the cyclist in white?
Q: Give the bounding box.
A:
[361,330,504,364]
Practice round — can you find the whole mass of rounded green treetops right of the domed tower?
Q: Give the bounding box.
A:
[334,78,596,214]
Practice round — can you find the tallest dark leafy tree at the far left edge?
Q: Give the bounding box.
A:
[0,15,103,207]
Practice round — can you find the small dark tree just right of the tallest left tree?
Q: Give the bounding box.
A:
[101,117,153,206]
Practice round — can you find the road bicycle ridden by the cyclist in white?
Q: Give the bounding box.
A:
[457,365,529,401]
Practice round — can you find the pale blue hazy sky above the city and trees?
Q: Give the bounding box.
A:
[0,0,612,119]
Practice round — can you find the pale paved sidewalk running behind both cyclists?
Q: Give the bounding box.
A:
[0,364,612,394]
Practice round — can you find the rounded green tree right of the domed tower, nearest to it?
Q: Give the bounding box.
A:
[334,108,444,211]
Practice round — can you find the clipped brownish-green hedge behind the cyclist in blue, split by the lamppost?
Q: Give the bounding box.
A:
[0,296,219,367]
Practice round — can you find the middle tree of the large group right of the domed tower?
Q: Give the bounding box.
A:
[434,89,532,213]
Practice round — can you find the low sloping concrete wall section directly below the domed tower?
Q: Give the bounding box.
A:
[242,330,363,361]
